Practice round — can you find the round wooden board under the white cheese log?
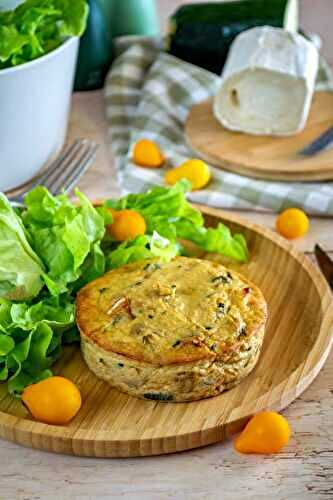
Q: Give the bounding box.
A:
[185,92,333,181]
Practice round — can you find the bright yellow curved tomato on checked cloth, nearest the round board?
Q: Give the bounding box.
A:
[165,160,211,191]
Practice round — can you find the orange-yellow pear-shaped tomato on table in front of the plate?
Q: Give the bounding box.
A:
[234,411,290,454]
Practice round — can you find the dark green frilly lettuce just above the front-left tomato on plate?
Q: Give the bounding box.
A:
[0,296,75,393]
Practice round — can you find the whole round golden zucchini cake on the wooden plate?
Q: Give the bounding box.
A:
[77,257,267,401]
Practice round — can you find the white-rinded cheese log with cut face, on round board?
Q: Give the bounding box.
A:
[213,26,319,135]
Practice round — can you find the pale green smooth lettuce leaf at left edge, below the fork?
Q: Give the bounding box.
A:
[0,193,44,300]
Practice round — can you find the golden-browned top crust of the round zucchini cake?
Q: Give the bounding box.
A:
[77,257,267,366]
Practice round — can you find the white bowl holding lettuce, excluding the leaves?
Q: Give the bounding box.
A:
[0,37,79,191]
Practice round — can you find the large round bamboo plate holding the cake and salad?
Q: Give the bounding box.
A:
[0,207,333,457]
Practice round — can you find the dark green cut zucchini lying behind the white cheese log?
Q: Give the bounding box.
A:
[167,0,298,74]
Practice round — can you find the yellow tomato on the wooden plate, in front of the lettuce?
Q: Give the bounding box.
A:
[22,377,82,425]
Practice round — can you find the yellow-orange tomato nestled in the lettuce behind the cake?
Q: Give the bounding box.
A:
[108,209,146,241]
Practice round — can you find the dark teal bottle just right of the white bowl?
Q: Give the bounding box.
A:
[74,0,113,90]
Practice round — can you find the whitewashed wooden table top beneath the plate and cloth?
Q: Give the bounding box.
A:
[0,92,333,500]
